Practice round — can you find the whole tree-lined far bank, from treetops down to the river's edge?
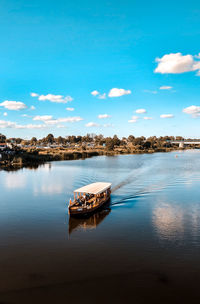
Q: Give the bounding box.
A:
[0,134,200,170]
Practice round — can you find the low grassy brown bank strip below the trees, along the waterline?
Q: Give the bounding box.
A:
[0,146,191,170]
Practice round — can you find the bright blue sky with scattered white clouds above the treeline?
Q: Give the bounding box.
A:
[0,0,200,138]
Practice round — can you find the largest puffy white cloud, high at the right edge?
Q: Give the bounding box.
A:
[154,53,200,74]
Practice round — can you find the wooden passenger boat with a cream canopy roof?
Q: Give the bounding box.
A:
[68,182,111,216]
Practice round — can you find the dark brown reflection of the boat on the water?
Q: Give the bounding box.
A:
[68,207,111,235]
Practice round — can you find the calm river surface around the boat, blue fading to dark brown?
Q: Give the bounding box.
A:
[0,150,200,303]
